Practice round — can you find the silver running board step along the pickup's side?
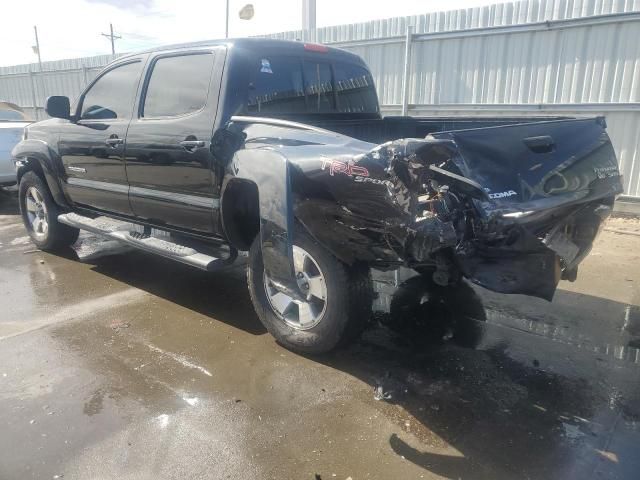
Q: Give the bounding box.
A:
[58,213,238,272]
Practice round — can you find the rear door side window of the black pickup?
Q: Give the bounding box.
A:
[142,53,214,118]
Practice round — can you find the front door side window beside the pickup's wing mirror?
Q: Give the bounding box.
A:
[80,62,142,120]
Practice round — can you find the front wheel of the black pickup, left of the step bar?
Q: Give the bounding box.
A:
[18,172,80,251]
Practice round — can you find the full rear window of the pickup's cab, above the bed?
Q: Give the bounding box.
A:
[247,55,378,115]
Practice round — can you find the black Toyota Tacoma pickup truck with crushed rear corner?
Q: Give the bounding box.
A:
[12,39,622,353]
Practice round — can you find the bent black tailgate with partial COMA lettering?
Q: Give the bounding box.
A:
[432,117,622,216]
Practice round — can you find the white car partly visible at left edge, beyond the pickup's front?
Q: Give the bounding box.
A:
[0,102,31,187]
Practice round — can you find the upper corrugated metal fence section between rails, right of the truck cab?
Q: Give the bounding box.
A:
[324,13,640,108]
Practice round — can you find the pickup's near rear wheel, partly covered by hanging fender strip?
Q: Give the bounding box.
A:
[247,230,373,354]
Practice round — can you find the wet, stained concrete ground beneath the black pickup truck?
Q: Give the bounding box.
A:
[0,188,640,480]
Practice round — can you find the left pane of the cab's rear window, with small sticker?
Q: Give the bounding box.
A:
[247,56,307,113]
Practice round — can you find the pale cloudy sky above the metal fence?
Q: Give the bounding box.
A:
[0,0,504,65]
